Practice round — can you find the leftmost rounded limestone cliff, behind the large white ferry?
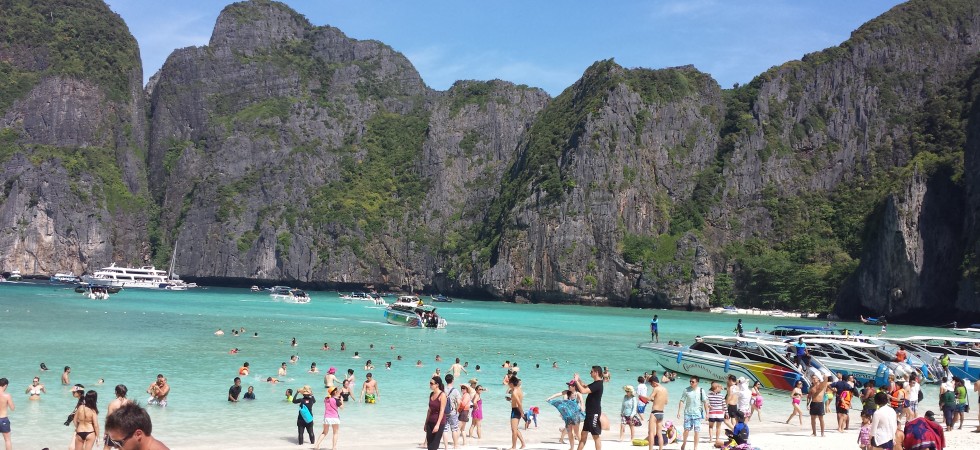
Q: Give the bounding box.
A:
[0,1,150,274]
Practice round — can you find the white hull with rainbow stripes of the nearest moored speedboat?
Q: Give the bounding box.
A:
[640,344,809,391]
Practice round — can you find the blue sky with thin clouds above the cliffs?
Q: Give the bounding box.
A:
[107,0,900,96]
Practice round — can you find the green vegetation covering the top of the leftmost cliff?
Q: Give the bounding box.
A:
[0,0,140,110]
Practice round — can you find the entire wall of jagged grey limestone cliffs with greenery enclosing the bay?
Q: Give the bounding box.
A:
[0,0,980,320]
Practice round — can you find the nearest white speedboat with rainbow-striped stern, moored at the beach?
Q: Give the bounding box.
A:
[638,336,812,392]
